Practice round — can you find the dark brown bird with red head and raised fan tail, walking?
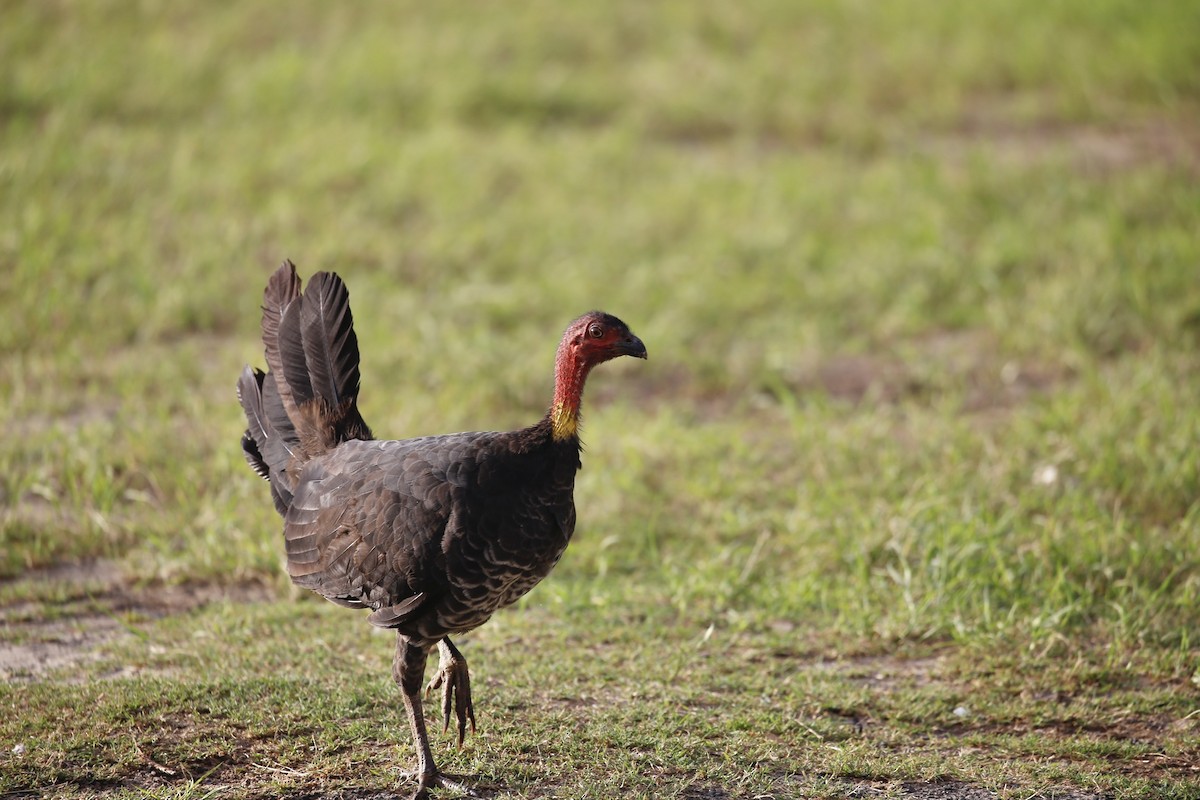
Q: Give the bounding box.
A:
[238,261,646,798]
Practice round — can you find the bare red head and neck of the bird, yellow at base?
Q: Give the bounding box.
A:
[551,311,647,440]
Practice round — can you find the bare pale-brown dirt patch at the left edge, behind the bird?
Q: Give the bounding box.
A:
[0,560,272,681]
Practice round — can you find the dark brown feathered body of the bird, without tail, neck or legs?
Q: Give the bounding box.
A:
[283,426,580,643]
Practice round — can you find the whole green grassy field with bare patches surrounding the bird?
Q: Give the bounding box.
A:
[0,0,1200,799]
